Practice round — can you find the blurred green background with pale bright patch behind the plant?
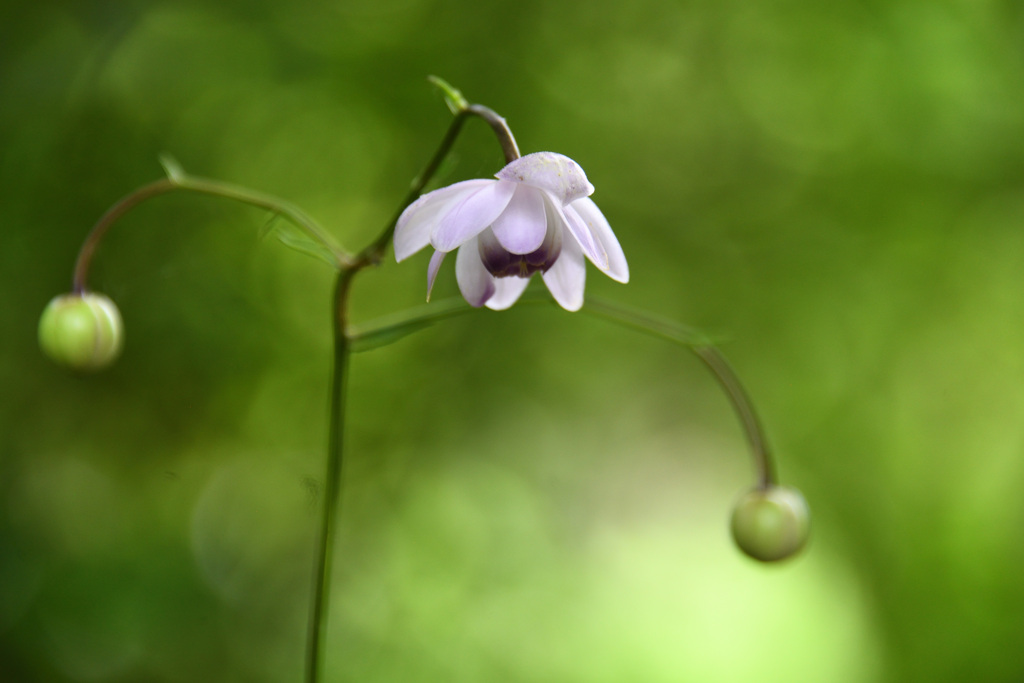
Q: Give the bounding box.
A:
[6,0,1024,683]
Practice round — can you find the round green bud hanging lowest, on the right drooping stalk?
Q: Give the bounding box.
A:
[732,486,811,562]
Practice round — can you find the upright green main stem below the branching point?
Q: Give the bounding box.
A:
[305,269,356,683]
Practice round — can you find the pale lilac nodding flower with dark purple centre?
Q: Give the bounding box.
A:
[394,152,630,310]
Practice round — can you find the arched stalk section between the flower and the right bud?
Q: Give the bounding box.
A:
[582,299,776,489]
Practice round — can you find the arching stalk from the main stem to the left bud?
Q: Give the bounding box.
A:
[72,173,352,293]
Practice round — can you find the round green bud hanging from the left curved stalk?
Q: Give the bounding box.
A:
[39,292,125,371]
